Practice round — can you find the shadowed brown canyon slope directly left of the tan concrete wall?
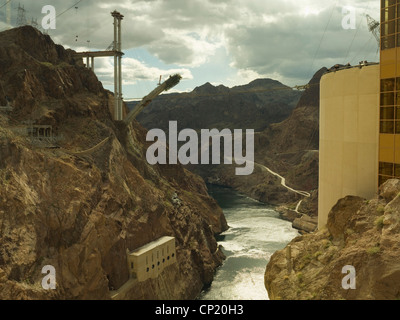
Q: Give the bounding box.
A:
[191,68,327,215]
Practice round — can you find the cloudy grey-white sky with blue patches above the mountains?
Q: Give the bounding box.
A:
[0,0,380,99]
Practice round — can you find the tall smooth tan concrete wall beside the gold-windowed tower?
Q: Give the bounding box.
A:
[318,65,380,229]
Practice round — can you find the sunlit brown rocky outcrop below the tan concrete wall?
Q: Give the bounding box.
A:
[265,180,400,300]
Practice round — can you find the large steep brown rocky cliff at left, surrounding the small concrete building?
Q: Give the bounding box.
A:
[0,27,227,299]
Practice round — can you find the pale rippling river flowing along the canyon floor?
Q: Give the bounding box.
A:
[199,186,299,300]
